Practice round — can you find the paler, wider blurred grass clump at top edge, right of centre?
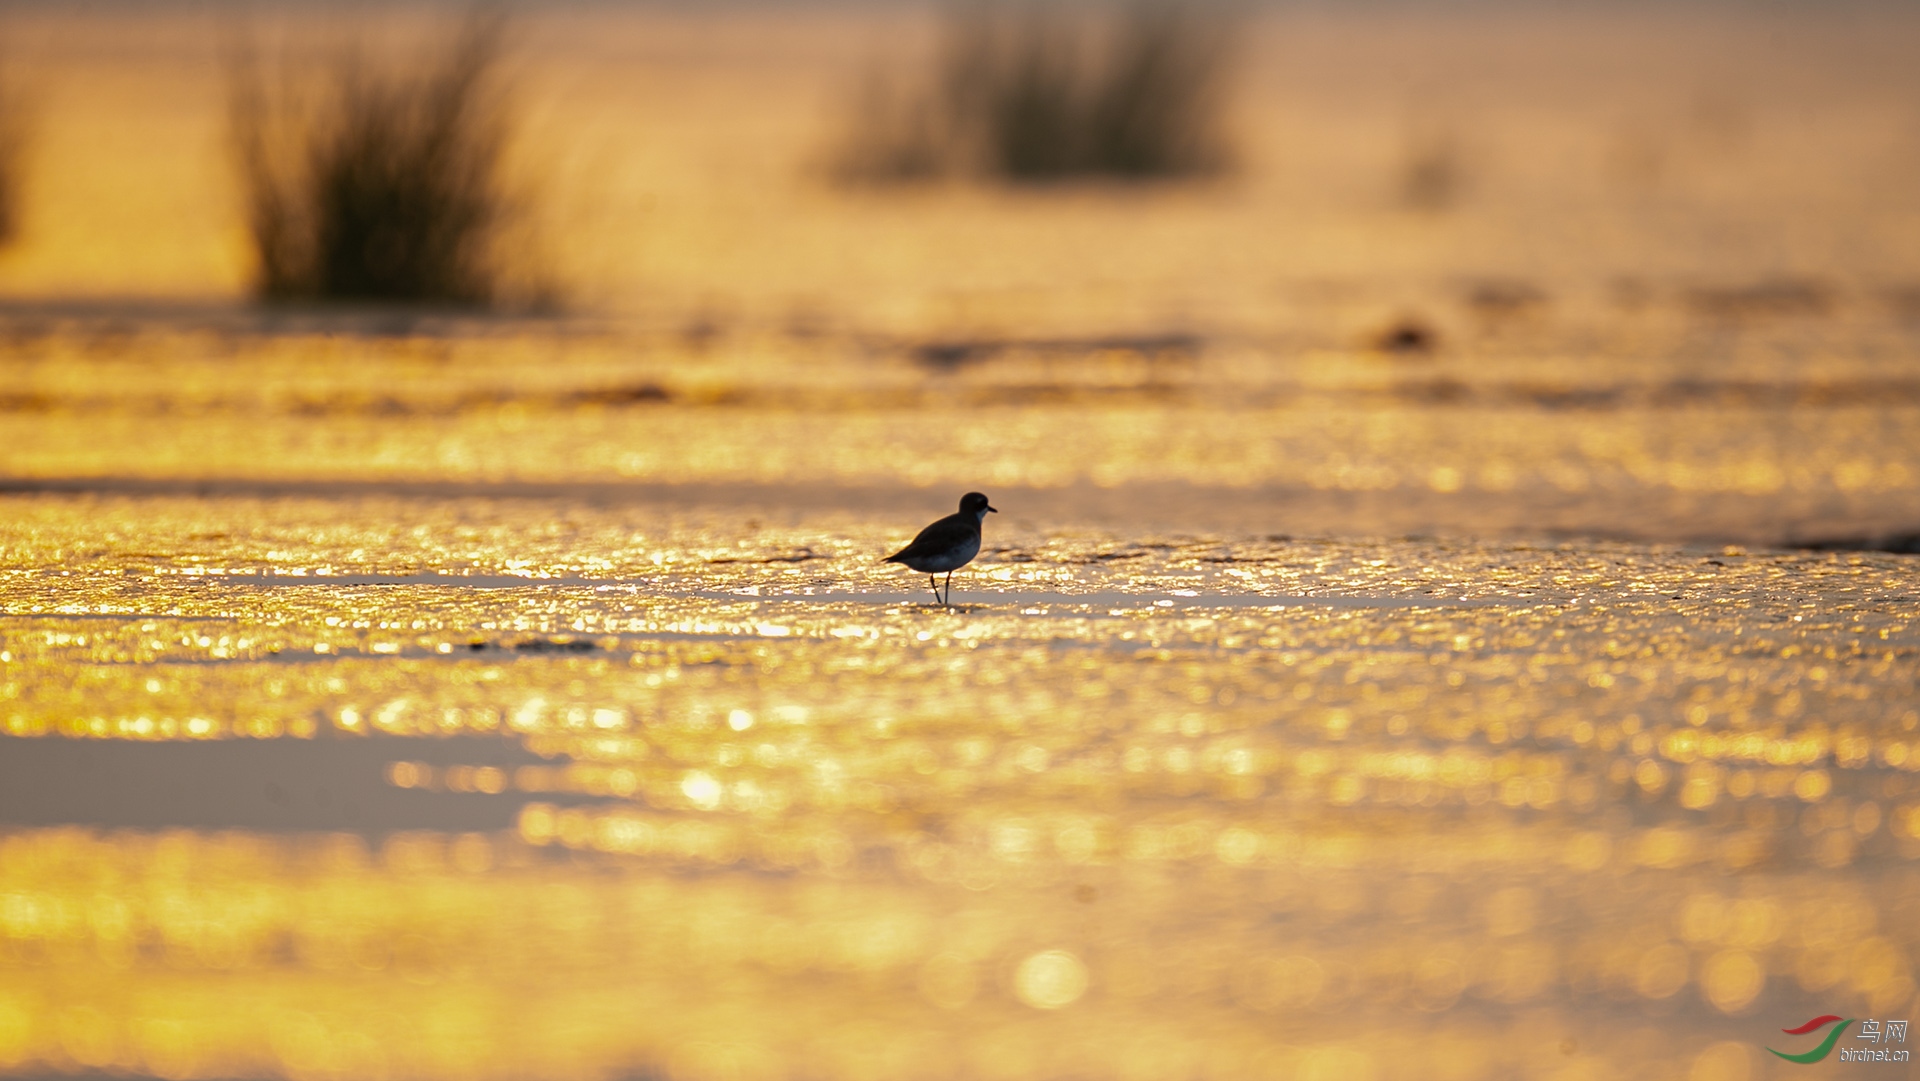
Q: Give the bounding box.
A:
[835,0,1231,182]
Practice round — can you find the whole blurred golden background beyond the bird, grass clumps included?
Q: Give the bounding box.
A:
[0,4,1920,547]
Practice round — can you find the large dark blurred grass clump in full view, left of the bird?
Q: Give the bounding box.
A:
[232,13,515,307]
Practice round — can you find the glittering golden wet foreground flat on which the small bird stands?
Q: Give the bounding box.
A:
[0,495,1920,1077]
